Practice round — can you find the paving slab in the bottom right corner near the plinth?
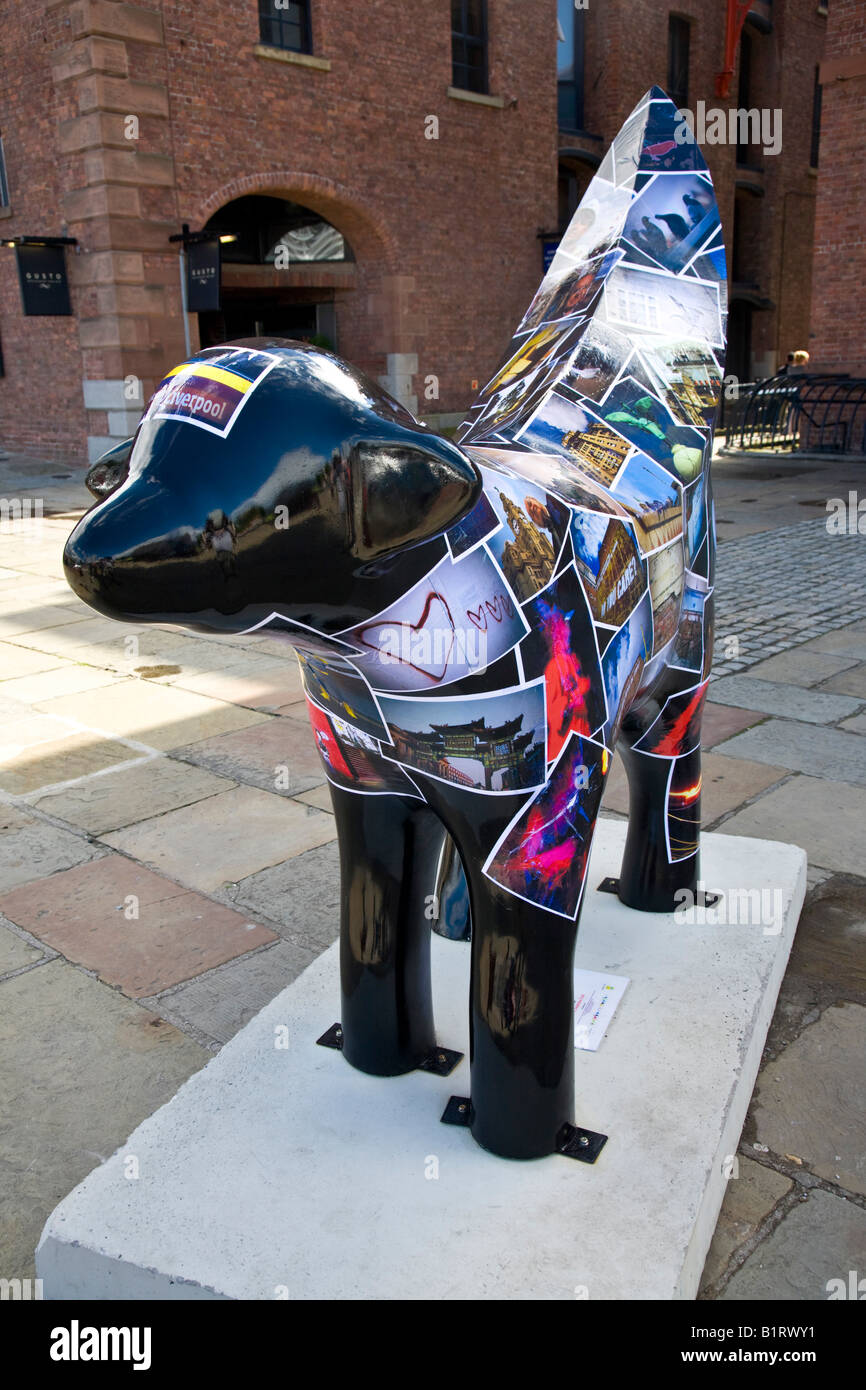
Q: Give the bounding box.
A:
[720,1190,866,1302]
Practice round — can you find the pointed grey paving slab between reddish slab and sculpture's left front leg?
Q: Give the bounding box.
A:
[229,840,341,955]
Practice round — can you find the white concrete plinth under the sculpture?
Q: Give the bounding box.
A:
[36,821,806,1300]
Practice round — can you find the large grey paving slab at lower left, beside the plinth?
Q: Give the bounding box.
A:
[0,960,210,1277]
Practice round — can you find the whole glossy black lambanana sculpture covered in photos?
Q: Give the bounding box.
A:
[65,89,726,1158]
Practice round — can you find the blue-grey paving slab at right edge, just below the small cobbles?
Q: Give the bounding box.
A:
[716,719,866,785]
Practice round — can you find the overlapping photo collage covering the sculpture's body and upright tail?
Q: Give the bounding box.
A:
[283,92,727,917]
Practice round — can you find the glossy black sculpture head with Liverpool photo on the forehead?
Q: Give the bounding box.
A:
[64,339,481,647]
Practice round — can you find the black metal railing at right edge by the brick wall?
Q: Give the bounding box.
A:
[717,371,866,453]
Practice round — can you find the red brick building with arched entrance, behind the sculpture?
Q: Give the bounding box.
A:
[0,0,839,461]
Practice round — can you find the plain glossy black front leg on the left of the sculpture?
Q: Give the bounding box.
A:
[331,785,445,1076]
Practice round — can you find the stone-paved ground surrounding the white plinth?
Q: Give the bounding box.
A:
[0,457,866,1300]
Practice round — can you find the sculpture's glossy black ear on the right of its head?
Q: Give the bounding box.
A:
[349,431,482,560]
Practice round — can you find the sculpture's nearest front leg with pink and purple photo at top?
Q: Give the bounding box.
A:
[428,773,603,1159]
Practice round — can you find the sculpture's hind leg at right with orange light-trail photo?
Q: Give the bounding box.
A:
[619,695,701,912]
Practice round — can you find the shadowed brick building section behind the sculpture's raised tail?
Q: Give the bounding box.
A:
[559,0,828,381]
